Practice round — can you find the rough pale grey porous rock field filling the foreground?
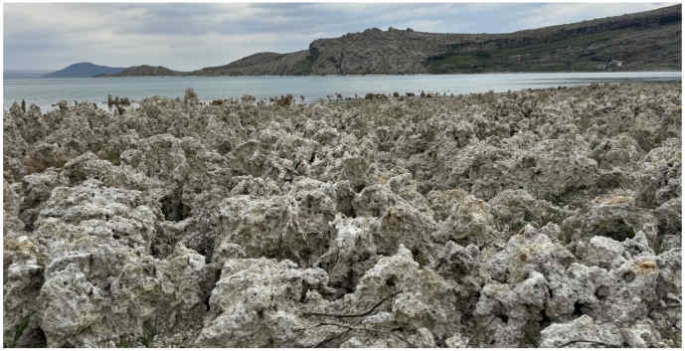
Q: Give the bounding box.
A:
[3,83,682,347]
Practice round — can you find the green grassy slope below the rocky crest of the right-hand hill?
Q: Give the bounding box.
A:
[425,12,681,73]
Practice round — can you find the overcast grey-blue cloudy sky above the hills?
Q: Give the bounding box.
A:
[4,3,669,70]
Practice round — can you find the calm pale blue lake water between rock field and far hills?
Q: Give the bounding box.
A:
[3,72,681,110]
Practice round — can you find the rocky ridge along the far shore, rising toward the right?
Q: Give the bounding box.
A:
[46,4,682,77]
